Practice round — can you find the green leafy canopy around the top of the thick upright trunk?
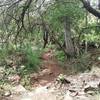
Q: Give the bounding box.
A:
[46,0,84,32]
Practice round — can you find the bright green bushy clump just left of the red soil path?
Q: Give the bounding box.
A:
[18,44,41,71]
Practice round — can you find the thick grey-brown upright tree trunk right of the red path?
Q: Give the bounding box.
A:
[64,17,75,57]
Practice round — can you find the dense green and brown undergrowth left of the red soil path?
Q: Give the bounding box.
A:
[0,44,42,87]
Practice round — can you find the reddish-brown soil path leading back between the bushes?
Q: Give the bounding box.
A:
[31,51,64,87]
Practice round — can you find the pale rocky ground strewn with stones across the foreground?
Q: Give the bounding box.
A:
[0,68,100,100]
